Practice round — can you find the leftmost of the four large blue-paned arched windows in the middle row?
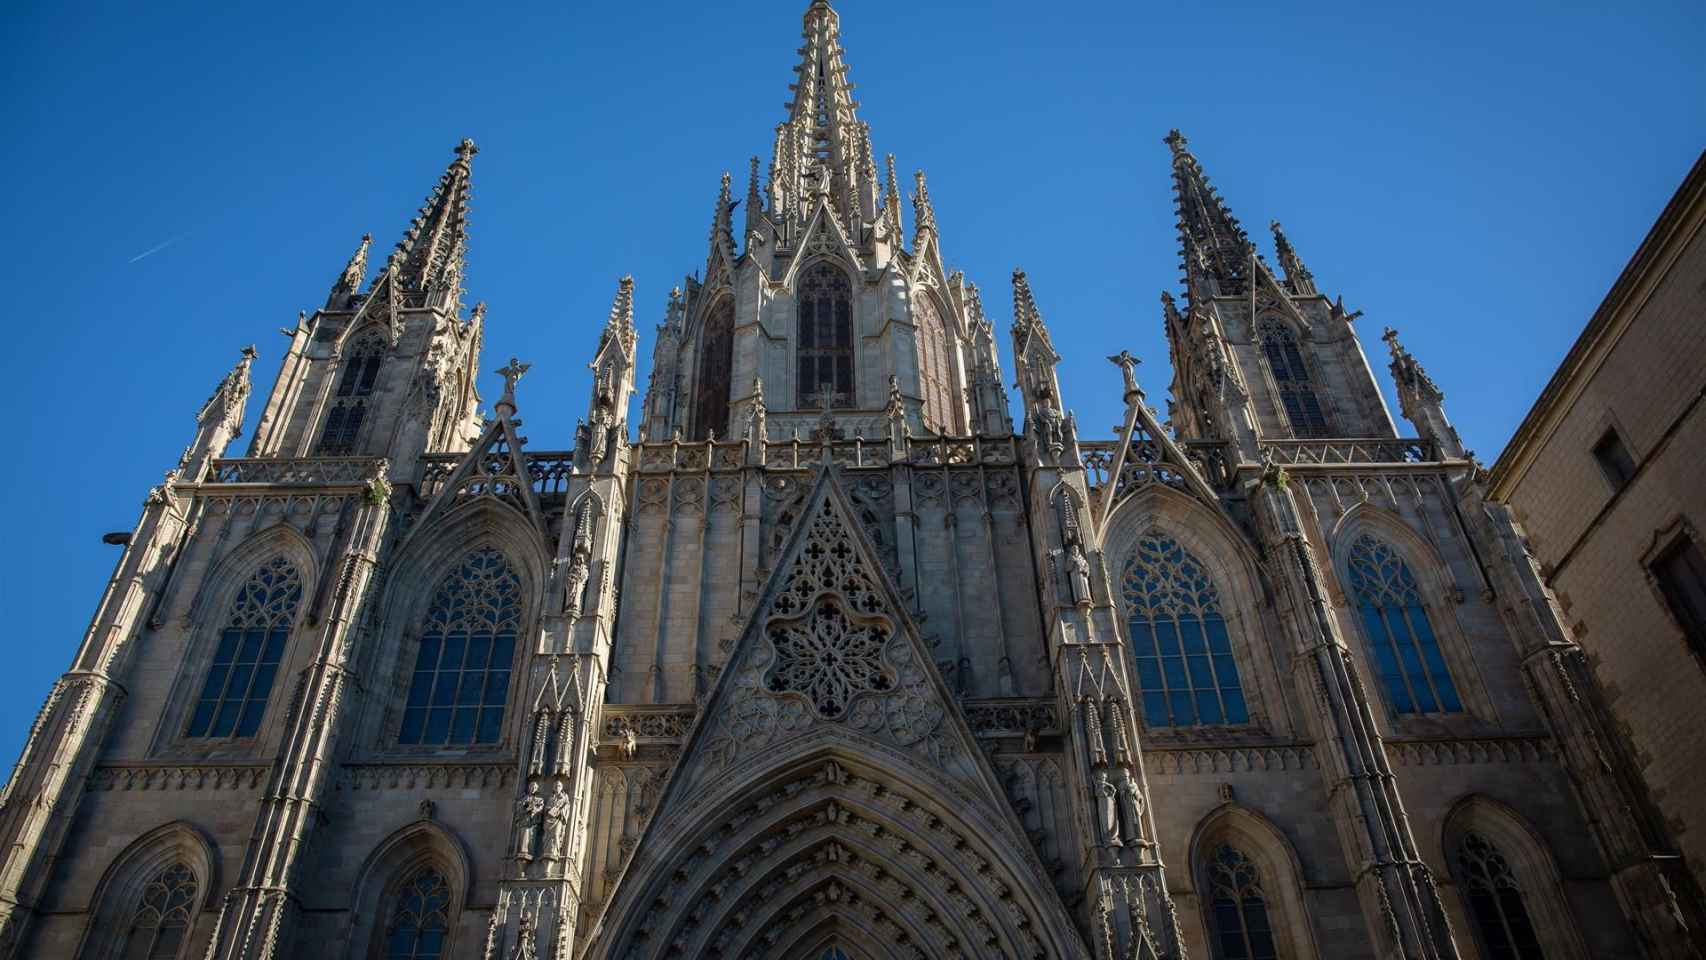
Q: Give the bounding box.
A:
[188,556,302,737]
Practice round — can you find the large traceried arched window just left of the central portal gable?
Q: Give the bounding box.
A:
[397,547,522,745]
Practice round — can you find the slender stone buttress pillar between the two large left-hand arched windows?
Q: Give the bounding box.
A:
[206,460,392,960]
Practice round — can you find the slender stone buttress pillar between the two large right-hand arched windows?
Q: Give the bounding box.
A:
[1250,464,1459,960]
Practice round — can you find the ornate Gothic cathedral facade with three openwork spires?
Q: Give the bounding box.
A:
[0,0,1706,960]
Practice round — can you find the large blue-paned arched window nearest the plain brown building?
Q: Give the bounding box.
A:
[1346,534,1464,713]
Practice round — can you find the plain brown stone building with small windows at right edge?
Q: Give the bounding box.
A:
[1489,153,1706,913]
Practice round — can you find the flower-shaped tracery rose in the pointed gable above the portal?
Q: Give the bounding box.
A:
[766,597,894,720]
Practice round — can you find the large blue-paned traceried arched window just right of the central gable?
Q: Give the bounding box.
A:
[1121,530,1250,726]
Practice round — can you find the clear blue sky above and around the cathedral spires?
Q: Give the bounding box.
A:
[0,0,1706,764]
